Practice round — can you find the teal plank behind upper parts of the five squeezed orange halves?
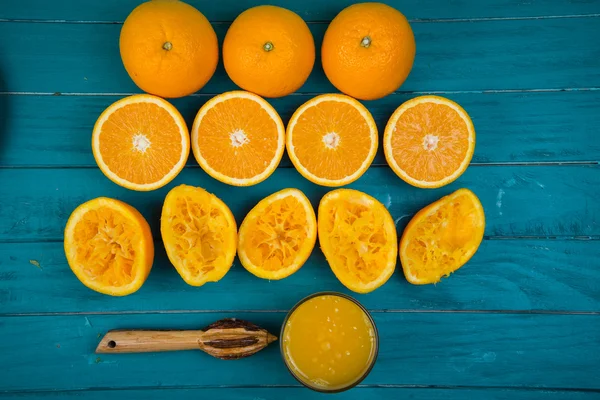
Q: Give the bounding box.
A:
[0,165,600,241]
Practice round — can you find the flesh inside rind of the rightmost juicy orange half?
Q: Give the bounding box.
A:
[391,103,469,182]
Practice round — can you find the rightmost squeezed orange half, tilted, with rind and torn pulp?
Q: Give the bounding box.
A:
[400,189,485,285]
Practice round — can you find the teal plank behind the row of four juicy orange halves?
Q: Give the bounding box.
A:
[0,91,600,166]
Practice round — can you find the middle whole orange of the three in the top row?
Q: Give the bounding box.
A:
[223,6,315,97]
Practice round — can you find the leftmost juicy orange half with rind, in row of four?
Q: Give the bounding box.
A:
[92,94,190,191]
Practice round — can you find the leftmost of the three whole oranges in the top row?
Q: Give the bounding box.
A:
[119,0,219,97]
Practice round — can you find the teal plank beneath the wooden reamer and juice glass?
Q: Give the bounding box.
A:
[0,312,600,390]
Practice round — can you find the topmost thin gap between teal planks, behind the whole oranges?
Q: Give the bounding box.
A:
[0,13,600,25]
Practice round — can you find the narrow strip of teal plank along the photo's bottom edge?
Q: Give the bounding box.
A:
[0,386,598,400]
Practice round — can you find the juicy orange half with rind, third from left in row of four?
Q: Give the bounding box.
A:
[286,94,378,186]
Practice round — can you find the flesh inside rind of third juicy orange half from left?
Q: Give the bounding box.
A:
[293,101,372,180]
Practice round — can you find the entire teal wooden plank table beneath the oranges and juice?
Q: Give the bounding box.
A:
[0,0,600,400]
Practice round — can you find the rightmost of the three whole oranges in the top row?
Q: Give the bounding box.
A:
[321,3,416,100]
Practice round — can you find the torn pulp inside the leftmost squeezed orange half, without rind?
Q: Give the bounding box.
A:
[73,207,142,287]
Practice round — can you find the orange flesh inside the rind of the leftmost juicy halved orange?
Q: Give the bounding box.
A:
[99,102,182,184]
